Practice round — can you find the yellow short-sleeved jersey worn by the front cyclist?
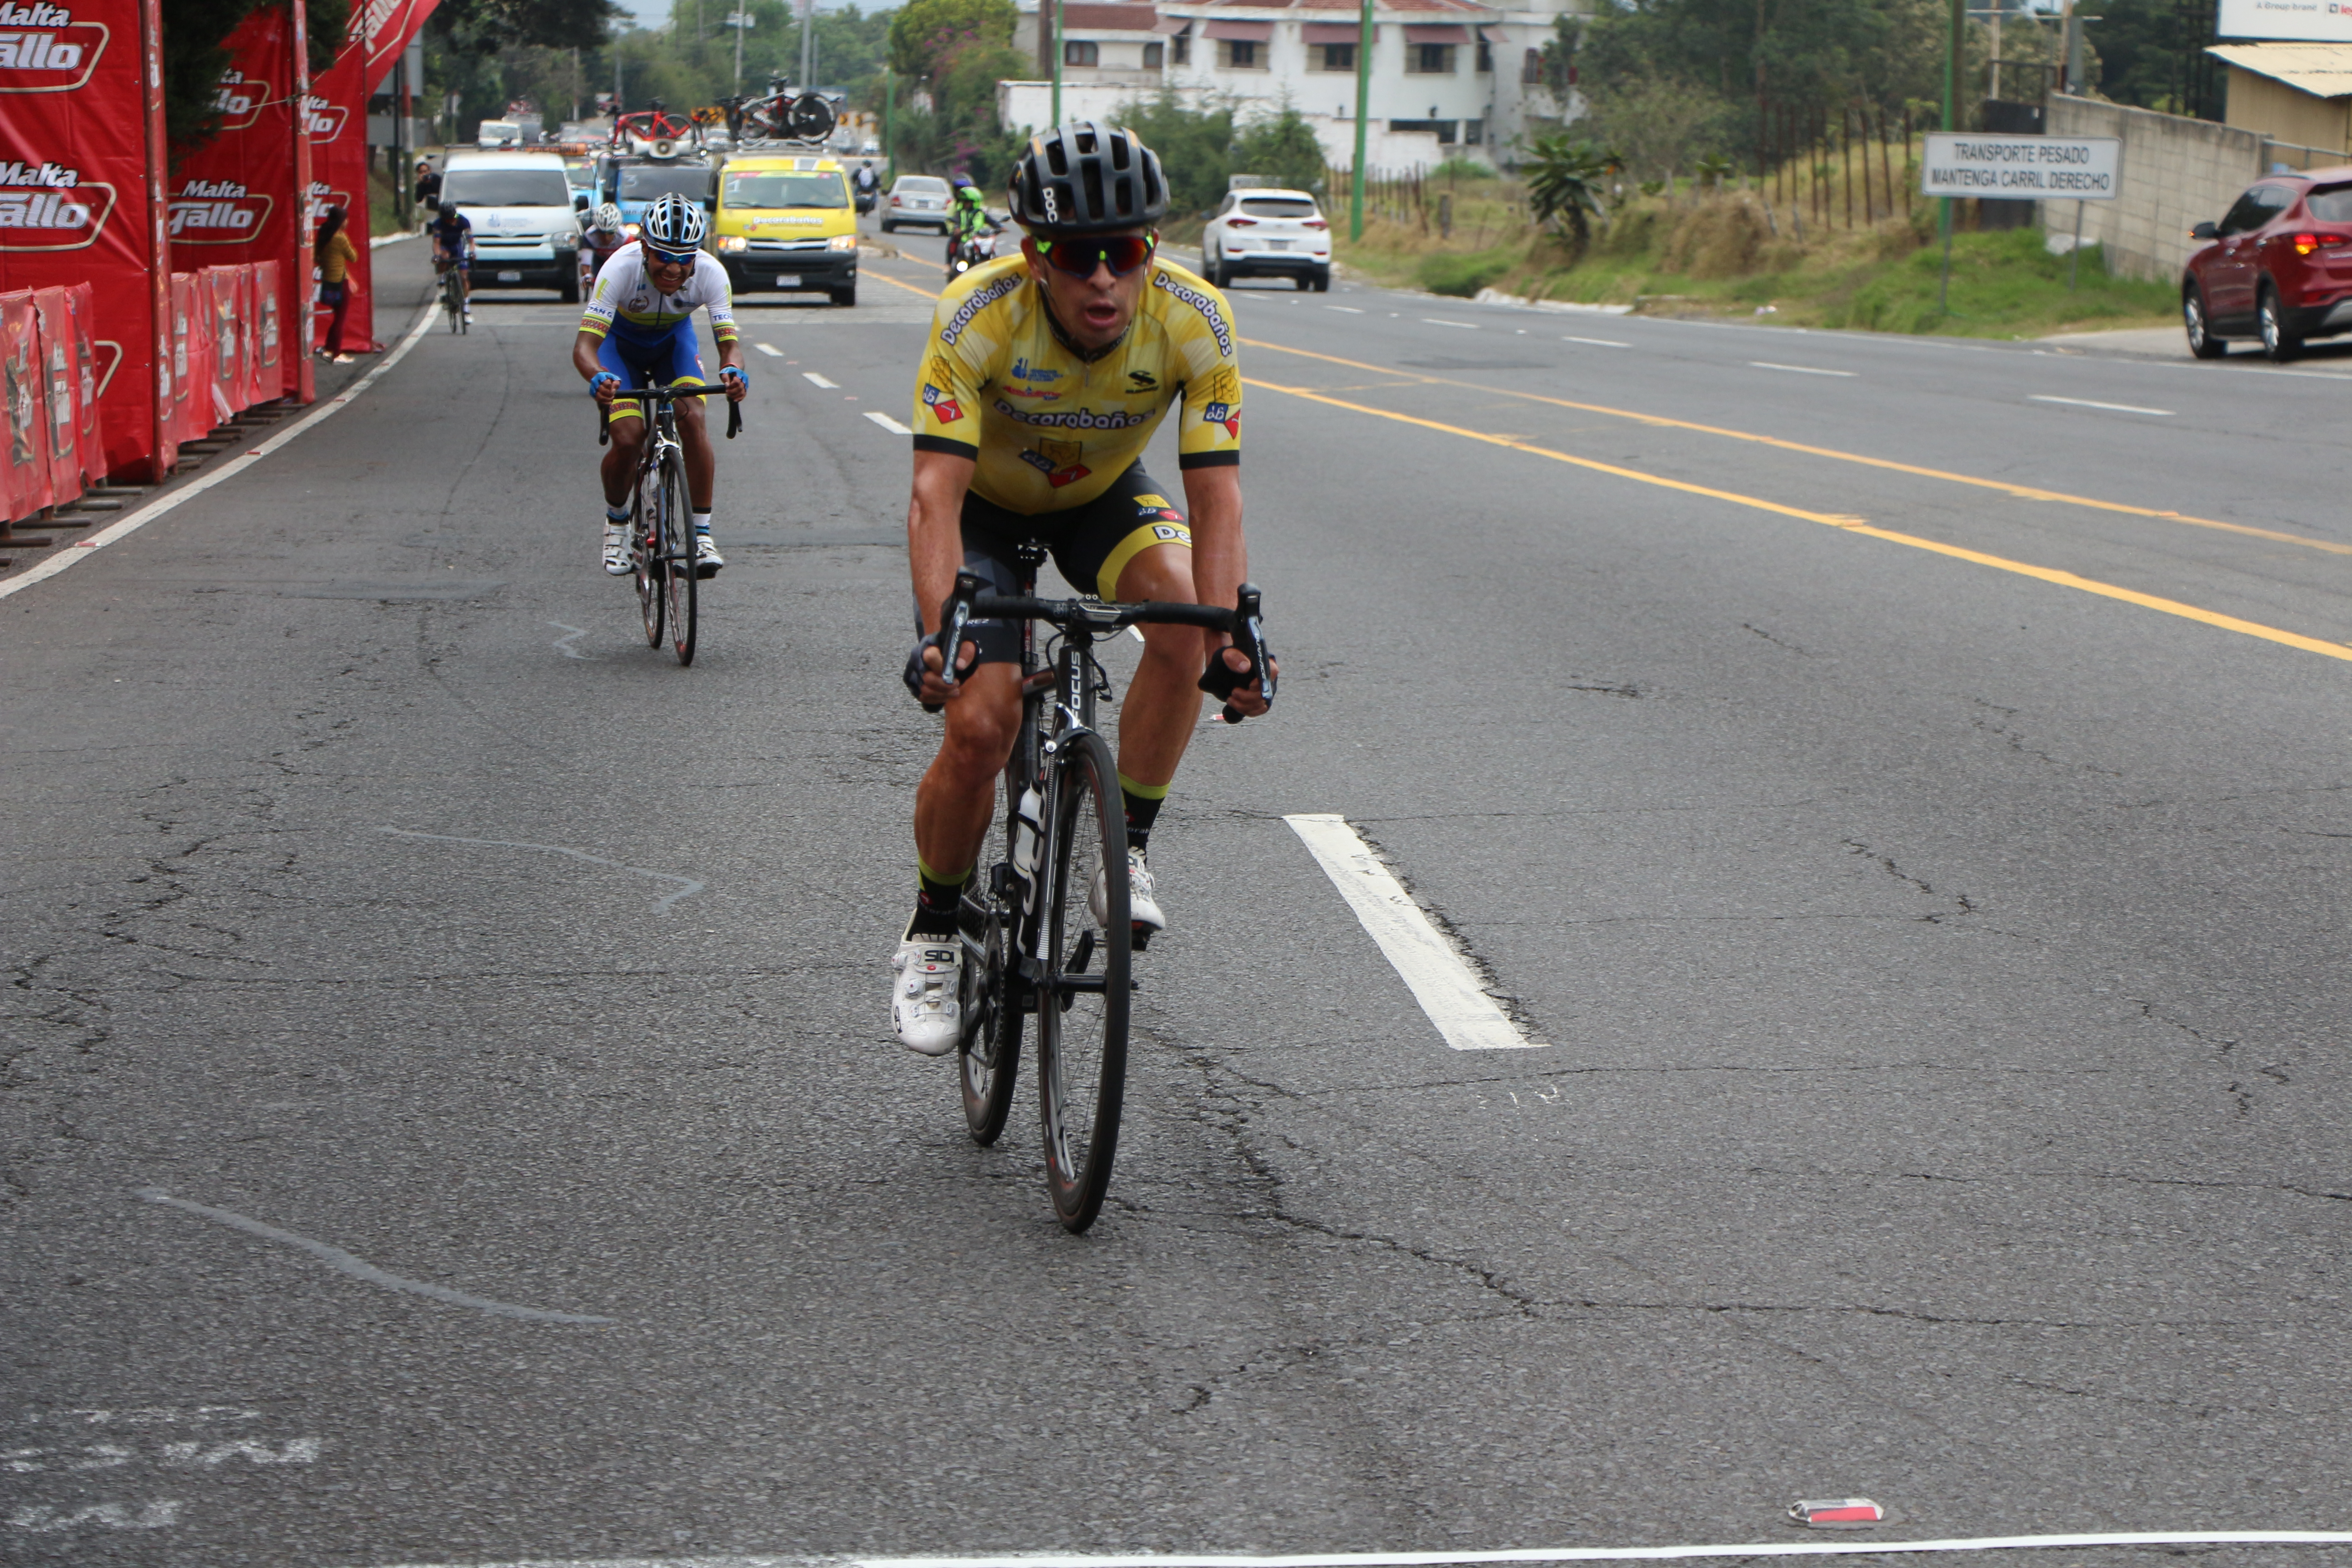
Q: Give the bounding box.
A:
[915,256,1242,515]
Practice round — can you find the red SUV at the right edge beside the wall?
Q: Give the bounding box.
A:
[2180,169,2352,360]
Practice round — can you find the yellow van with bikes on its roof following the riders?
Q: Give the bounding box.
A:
[710,153,858,306]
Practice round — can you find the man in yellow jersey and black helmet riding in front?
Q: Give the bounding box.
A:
[892,120,1279,1055]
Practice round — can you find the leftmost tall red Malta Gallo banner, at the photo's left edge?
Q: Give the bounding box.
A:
[0,0,174,477]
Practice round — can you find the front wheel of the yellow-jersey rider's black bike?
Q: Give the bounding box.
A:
[1037,736,1132,1232]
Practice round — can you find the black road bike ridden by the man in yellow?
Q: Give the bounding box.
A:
[938,557,1275,1232]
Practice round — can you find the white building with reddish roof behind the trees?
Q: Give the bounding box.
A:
[997,0,1590,172]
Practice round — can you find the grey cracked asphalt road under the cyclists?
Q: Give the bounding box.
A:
[0,223,2352,1568]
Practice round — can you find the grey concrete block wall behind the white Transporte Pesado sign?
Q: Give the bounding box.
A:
[2042,94,2263,282]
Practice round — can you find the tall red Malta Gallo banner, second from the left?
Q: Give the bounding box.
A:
[170,0,318,402]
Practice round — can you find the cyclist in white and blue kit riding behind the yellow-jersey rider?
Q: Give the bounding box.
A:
[572,193,750,576]
